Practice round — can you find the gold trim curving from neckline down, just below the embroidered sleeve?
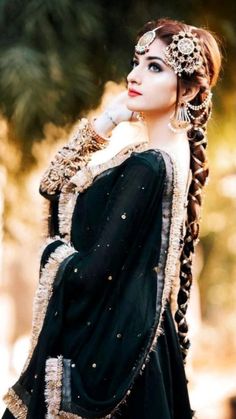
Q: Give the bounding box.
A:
[58,142,148,242]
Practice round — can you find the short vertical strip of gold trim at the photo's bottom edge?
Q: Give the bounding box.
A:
[44,355,63,419]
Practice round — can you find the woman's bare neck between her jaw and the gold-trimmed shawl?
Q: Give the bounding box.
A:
[145,111,187,150]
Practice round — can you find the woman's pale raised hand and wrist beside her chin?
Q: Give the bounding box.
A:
[93,90,137,136]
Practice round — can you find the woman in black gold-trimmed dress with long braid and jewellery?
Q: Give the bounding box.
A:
[3,19,221,419]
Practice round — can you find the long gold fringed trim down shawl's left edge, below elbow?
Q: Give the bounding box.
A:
[23,243,75,372]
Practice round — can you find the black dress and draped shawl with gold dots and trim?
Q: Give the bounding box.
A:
[3,146,192,419]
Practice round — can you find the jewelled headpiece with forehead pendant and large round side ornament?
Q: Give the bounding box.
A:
[135,26,203,77]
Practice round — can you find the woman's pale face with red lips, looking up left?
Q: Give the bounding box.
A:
[127,39,177,116]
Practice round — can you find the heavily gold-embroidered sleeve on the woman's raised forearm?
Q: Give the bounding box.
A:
[40,118,107,195]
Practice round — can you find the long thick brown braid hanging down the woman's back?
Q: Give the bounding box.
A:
[175,102,211,361]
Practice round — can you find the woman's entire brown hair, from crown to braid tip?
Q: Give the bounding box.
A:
[138,19,221,361]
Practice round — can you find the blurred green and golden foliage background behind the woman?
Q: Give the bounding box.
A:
[0,0,236,419]
